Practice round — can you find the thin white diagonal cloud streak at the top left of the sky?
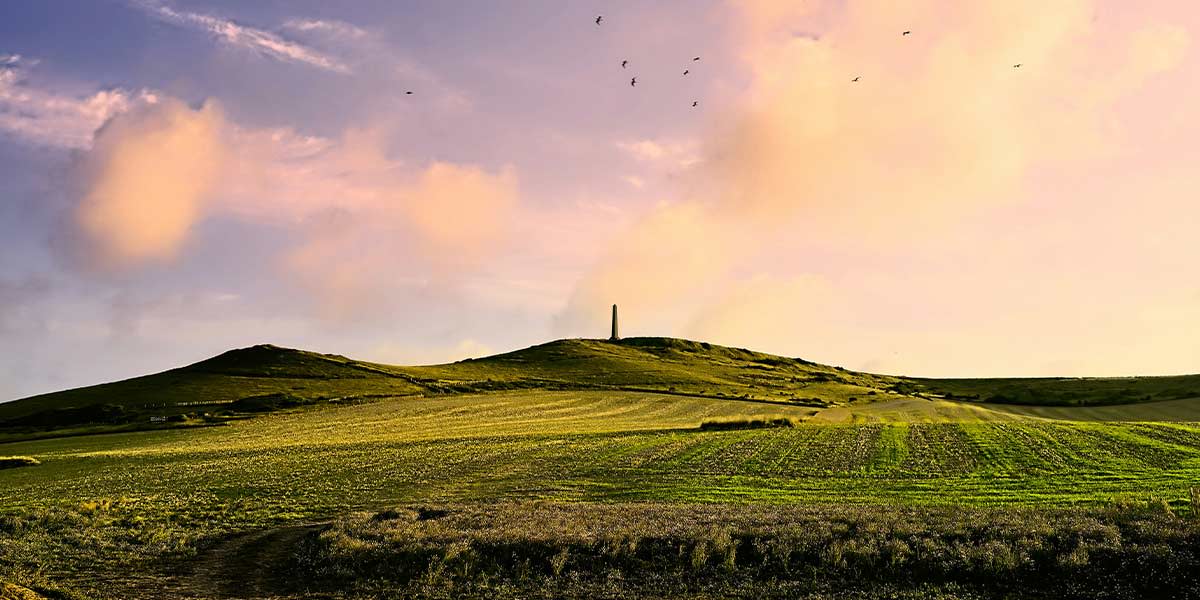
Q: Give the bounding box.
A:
[133,0,350,73]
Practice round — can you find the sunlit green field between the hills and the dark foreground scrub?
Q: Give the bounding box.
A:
[7,391,1200,598]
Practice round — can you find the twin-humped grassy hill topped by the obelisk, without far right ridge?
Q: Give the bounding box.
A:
[0,338,899,428]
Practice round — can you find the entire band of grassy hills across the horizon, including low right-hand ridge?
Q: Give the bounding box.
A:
[0,337,1200,434]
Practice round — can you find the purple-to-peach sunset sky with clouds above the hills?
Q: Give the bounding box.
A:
[0,0,1200,401]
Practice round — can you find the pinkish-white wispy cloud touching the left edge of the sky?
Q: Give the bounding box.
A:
[0,54,158,149]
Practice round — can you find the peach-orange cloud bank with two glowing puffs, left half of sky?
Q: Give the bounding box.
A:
[62,98,520,317]
